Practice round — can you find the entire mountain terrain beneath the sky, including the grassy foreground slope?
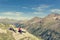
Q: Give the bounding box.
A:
[0,13,60,40]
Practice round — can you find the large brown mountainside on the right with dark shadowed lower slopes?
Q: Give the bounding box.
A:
[26,13,60,40]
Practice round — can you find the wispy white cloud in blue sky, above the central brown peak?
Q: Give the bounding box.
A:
[32,5,50,14]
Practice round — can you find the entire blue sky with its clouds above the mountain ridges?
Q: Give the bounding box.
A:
[0,0,60,20]
